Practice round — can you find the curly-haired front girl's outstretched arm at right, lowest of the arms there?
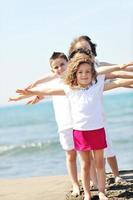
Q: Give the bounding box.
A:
[104,79,133,91]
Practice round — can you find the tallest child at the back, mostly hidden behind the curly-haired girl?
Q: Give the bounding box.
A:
[69,35,133,183]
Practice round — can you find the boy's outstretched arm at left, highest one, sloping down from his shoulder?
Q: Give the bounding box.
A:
[25,73,58,89]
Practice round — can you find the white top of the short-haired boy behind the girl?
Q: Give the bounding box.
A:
[52,78,72,132]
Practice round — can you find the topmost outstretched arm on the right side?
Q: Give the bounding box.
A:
[96,62,133,75]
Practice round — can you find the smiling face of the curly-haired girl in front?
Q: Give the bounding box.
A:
[76,63,92,87]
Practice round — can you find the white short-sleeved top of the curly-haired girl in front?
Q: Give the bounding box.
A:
[64,75,105,130]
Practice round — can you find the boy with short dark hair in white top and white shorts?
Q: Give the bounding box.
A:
[9,52,80,196]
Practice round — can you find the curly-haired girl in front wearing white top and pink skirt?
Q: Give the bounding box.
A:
[14,54,133,200]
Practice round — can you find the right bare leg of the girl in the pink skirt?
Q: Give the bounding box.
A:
[94,150,108,200]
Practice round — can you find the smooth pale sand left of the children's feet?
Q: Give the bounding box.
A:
[0,176,71,200]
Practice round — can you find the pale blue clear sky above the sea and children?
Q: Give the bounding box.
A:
[0,0,133,106]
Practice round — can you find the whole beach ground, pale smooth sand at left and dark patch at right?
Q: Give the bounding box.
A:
[0,170,133,200]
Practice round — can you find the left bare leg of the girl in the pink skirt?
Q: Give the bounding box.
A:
[80,151,91,200]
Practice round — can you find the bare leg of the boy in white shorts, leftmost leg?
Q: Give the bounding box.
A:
[66,150,80,196]
